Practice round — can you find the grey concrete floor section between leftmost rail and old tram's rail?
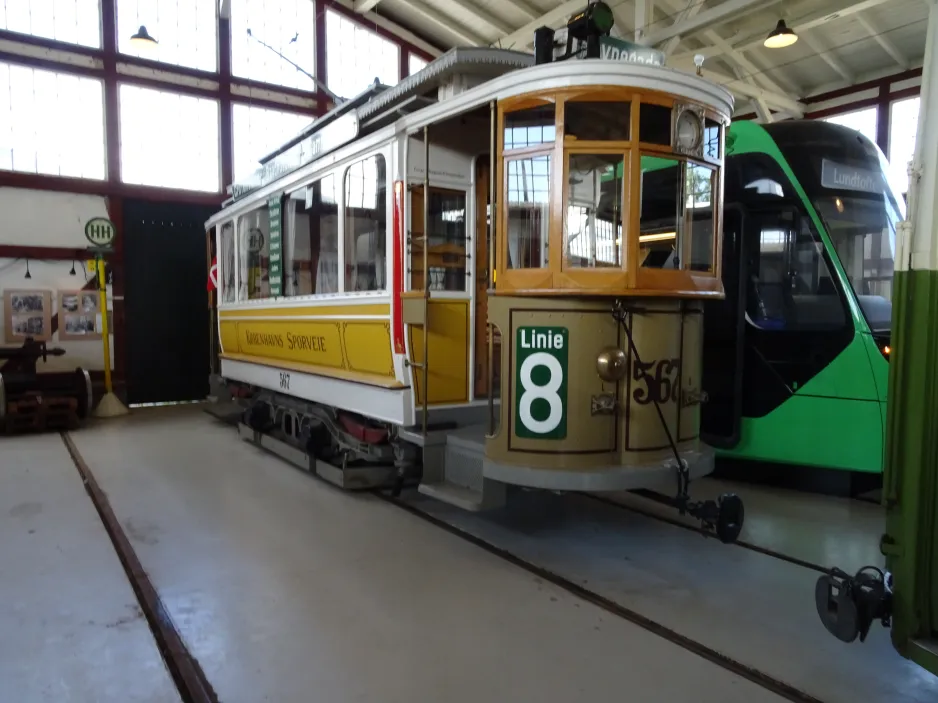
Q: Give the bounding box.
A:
[18,409,782,703]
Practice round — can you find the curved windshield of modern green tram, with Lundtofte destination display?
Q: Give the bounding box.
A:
[764,122,905,334]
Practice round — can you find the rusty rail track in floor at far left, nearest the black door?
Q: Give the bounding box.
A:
[61,432,218,703]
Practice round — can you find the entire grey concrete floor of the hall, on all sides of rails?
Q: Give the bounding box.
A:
[0,407,938,703]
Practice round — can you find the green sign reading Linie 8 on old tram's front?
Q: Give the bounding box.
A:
[515,327,570,439]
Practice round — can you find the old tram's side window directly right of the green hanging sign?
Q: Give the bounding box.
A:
[284,174,339,296]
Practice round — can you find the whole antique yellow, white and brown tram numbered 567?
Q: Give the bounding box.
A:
[207,3,742,539]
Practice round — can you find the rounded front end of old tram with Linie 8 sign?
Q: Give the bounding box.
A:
[483,8,743,541]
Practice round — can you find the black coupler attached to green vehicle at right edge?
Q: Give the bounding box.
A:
[814,566,892,643]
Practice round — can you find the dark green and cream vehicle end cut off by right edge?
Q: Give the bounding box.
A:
[882,0,938,675]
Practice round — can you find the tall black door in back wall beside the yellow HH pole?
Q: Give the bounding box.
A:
[123,200,218,404]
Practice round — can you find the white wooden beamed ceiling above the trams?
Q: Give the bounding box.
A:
[339,0,928,119]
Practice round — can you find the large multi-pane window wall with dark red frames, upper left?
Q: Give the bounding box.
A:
[0,0,431,201]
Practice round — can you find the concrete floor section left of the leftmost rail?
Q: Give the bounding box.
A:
[0,434,179,703]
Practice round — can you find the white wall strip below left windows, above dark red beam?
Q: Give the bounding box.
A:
[0,188,108,248]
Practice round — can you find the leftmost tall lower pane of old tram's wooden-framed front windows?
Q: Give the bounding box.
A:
[506,155,551,269]
